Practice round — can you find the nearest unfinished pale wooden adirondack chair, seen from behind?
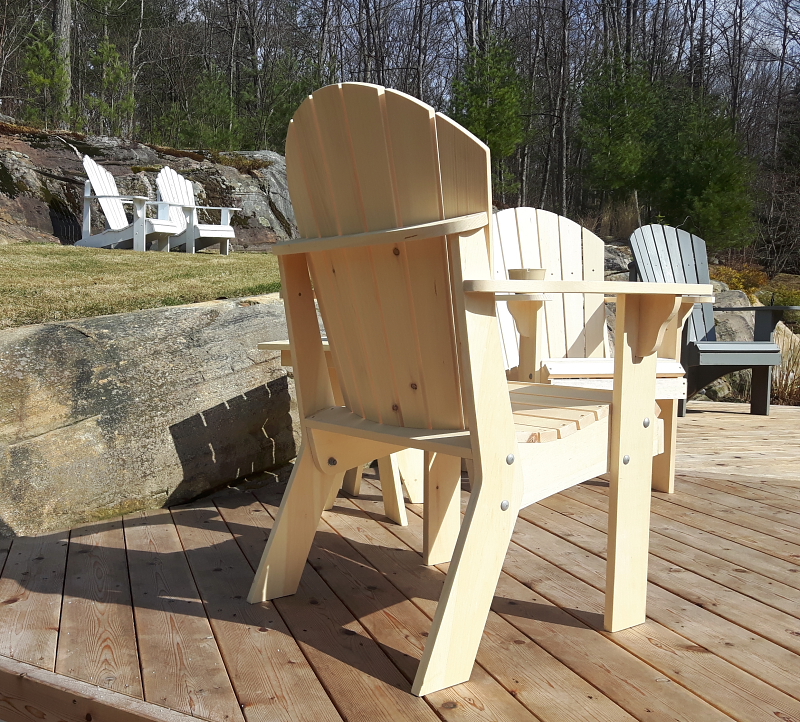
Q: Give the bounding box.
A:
[248,83,711,695]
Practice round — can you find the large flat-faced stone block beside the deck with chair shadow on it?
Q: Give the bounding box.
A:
[0,295,297,535]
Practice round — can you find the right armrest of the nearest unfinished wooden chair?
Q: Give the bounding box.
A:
[464,279,713,301]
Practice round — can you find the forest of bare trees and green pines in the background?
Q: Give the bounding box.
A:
[0,0,800,268]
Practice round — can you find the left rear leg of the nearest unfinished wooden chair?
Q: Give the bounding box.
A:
[247,445,341,604]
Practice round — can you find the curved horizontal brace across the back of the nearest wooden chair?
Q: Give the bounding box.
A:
[272,213,489,256]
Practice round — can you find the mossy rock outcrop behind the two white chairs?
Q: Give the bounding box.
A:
[0,128,297,251]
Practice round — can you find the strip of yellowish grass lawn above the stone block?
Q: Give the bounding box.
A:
[0,243,280,329]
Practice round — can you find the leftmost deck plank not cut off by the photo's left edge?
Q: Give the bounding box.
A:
[55,519,143,699]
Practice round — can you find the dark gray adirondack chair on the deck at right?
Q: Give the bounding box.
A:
[631,225,783,416]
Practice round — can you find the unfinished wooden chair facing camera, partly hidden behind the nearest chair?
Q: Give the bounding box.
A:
[492,208,692,493]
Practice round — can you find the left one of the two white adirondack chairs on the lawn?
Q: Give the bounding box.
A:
[75,155,178,251]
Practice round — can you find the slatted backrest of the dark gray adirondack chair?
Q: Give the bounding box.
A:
[631,225,717,341]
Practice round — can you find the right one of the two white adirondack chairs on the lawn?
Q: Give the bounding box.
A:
[156,166,241,256]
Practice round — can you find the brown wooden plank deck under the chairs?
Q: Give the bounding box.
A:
[0,404,800,722]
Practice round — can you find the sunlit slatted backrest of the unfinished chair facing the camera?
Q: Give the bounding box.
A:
[494,208,608,369]
